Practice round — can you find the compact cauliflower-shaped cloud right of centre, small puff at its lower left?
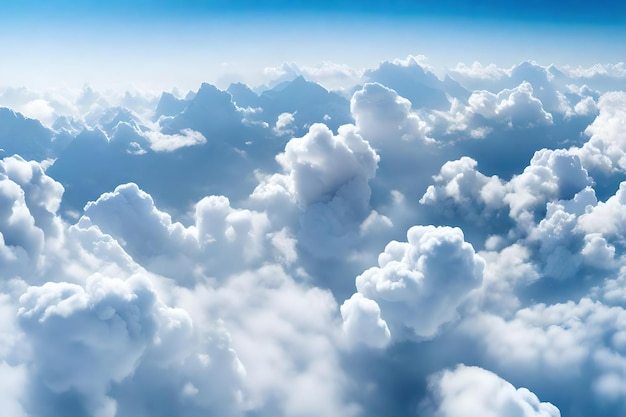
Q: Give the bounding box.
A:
[343,226,485,345]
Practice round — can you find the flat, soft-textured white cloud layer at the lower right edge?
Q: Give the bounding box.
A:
[465,298,625,413]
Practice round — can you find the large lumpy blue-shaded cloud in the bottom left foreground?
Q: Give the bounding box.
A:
[18,274,243,417]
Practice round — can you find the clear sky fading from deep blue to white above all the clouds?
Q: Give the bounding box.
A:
[0,0,626,90]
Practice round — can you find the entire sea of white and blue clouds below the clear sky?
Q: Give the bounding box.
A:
[0,56,626,417]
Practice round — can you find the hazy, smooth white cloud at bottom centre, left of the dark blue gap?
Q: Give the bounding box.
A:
[177,265,359,417]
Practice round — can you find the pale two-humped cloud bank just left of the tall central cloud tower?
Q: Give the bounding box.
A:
[79,184,276,285]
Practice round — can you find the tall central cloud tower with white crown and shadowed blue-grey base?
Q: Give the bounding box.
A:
[252,120,386,258]
